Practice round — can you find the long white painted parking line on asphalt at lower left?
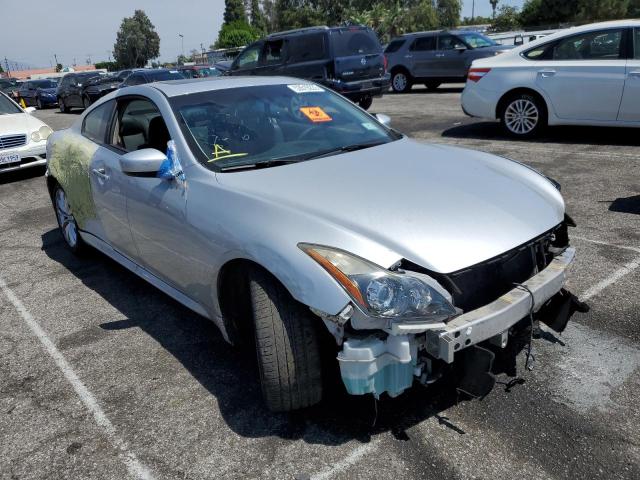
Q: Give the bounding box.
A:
[0,278,154,480]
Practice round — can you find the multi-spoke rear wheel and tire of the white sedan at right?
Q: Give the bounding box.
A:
[500,93,547,138]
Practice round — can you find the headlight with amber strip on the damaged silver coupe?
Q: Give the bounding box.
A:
[298,243,457,323]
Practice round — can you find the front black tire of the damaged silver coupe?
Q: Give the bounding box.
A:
[248,268,322,412]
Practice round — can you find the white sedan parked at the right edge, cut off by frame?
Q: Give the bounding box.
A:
[462,20,640,137]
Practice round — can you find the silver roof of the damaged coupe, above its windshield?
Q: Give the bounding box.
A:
[146,76,312,97]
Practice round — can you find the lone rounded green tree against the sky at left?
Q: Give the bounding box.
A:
[113,10,160,68]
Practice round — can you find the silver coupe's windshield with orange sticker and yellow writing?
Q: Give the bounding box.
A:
[170,84,400,170]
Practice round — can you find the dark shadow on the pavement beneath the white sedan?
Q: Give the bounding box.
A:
[442,121,640,146]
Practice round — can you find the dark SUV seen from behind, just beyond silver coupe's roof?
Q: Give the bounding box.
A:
[230,26,390,109]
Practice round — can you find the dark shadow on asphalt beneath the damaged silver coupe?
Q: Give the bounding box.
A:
[42,229,490,445]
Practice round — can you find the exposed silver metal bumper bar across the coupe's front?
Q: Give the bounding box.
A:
[390,248,575,363]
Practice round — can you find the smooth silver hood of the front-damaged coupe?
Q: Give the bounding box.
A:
[216,138,564,273]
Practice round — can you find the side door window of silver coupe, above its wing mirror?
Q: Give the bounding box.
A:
[110,97,171,153]
